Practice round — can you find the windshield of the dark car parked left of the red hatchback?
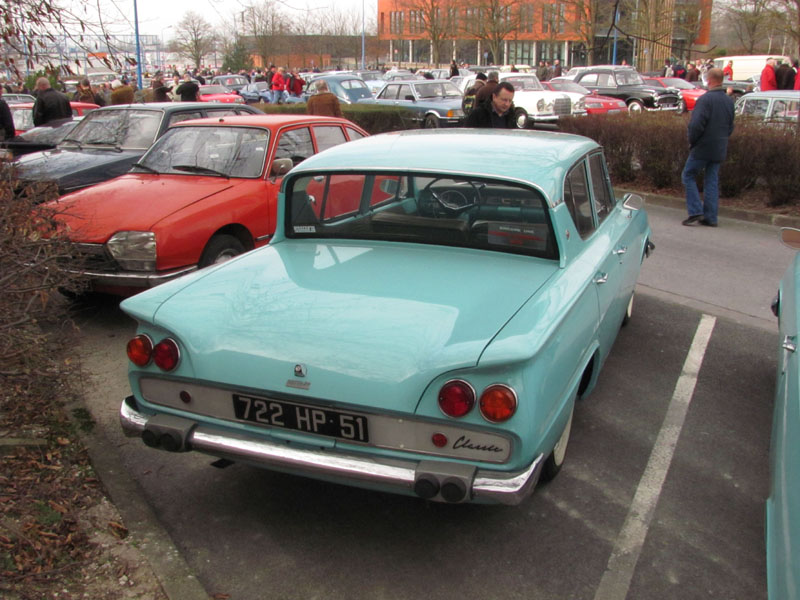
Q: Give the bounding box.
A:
[67,108,164,149]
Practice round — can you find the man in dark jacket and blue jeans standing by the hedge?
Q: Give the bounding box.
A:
[681,69,733,227]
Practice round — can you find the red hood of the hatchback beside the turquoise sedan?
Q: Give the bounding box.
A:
[49,174,234,243]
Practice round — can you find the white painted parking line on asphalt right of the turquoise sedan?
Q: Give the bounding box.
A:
[594,315,716,600]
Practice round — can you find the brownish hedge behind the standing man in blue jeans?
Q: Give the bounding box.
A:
[560,113,800,206]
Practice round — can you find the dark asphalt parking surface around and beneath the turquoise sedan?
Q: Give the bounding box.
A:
[78,228,777,600]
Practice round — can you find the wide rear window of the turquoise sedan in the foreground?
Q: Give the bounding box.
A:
[285,172,558,258]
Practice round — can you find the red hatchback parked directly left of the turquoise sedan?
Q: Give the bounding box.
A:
[48,115,368,295]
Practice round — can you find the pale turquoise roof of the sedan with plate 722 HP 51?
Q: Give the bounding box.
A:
[292,129,600,202]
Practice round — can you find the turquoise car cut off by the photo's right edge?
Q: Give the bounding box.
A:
[766,229,800,600]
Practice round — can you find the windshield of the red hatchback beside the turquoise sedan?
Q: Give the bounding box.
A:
[139,126,269,177]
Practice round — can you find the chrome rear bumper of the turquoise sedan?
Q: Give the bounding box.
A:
[120,396,544,505]
